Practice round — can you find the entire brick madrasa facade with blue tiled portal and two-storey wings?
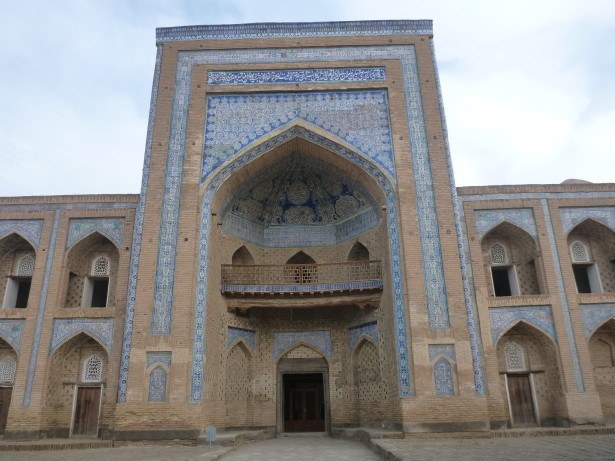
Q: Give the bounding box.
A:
[0,20,615,440]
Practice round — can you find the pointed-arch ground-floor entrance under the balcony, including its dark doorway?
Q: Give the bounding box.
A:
[277,345,330,432]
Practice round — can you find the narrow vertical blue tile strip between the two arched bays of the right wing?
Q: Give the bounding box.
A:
[540,198,585,392]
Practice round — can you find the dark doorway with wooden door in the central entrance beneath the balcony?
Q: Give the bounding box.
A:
[282,373,325,432]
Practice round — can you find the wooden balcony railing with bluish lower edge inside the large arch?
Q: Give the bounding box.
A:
[221,261,382,293]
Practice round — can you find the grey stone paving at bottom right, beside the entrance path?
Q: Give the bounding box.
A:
[372,435,615,461]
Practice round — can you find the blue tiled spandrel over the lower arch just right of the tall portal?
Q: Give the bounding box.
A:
[489,306,557,344]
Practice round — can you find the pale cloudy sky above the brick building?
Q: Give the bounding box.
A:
[0,0,615,196]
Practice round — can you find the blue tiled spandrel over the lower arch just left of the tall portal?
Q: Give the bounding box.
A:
[49,318,113,355]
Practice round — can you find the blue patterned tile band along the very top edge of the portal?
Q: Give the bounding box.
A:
[156,19,433,43]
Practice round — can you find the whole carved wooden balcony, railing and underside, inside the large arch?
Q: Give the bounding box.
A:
[220,261,382,310]
